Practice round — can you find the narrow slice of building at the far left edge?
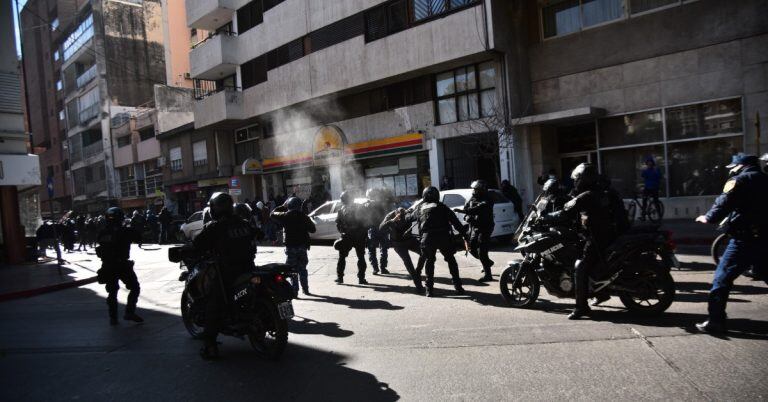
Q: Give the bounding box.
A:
[0,2,40,264]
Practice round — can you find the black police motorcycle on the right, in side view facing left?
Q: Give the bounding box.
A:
[499,187,677,315]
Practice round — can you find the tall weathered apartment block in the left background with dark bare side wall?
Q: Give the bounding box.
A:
[21,0,165,215]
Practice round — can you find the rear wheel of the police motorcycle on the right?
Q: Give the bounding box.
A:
[619,269,675,315]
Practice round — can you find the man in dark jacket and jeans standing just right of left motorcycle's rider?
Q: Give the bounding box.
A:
[271,197,315,295]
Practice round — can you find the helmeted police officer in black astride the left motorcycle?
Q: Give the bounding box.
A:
[193,192,256,359]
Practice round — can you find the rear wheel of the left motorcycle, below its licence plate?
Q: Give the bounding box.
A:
[248,300,288,360]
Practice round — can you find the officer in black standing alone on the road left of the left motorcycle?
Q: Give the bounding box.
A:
[96,207,144,325]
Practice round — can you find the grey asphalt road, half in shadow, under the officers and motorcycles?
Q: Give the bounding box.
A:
[0,246,768,401]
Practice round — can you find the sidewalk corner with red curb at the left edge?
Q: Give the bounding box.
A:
[0,252,100,302]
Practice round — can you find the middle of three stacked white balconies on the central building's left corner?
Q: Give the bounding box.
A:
[189,32,237,80]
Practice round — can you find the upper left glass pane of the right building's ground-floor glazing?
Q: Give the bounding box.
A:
[599,110,664,147]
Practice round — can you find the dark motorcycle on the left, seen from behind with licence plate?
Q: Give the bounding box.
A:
[168,246,296,360]
